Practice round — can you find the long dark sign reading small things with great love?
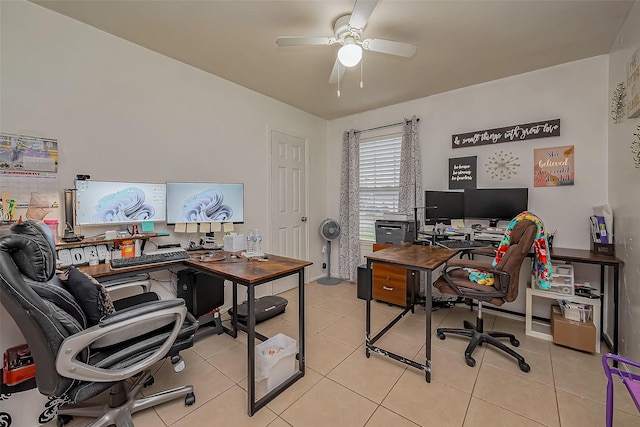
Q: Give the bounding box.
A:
[451,119,560,148]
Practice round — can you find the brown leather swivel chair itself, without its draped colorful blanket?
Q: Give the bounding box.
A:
[433,220,536,372]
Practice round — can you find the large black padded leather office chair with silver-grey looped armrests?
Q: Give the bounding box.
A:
[0,221,197,426]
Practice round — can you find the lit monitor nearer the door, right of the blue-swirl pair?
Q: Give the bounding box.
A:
[167,182,244,224]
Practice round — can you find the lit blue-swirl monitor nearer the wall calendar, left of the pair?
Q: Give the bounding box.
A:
[75,180,167,225]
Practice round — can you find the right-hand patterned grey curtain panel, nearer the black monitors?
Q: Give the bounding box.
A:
[398,116,424,226]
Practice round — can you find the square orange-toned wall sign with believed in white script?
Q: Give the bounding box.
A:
[533,145,575,187]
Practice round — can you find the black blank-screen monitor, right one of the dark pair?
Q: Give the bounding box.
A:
[464,188,529,227]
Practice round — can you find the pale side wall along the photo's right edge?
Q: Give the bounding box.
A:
[608,1,640,360]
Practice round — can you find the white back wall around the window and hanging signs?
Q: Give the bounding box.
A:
[327,56,608,316]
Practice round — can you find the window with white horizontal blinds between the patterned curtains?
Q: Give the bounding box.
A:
[359,134,402,242]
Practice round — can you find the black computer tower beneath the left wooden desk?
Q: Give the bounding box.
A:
[177,270,224,318]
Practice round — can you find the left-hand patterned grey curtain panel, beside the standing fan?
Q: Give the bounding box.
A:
[339,129,360,282]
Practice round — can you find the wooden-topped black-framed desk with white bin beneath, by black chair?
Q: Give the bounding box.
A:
[82,252,313,416]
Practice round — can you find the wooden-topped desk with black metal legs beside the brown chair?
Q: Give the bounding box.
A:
[366,243,458,382]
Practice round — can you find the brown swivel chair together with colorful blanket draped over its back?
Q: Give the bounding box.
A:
[434,212,550,372]
